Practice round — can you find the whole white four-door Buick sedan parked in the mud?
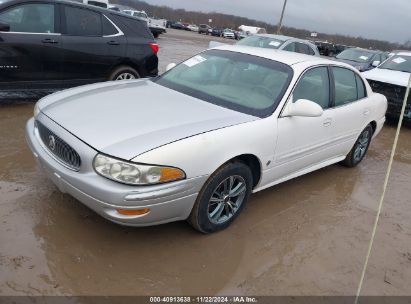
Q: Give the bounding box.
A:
[26,46,387,233]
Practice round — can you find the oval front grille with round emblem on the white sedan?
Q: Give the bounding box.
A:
[36,121,81,171]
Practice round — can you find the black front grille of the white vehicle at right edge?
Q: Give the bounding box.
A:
[368,80,411,118]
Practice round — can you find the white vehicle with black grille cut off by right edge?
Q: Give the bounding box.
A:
[363,51,411,122]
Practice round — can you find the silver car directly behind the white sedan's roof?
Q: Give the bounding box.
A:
[237,34,320,56]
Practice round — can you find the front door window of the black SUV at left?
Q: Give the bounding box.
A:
[0,3,55,33]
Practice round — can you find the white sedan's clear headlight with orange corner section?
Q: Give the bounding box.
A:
[93,154,186,185]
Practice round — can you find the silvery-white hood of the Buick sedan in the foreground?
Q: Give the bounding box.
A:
[38,79,258,159]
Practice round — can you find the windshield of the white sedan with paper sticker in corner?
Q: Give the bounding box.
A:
[153,50,293,117]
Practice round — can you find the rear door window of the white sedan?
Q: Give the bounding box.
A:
[332,67,358,107]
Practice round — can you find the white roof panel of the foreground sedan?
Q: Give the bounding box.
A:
[213,45,338,66]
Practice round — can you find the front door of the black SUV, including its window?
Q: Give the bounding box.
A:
[0,2,61,89]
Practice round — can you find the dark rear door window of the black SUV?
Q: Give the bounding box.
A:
[64,6,102,36]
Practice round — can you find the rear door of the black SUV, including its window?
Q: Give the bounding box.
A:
[61,4,126,84]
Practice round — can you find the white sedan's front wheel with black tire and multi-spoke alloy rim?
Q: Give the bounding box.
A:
[188,162,253,233]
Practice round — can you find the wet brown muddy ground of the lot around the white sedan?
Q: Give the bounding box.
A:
[0,30,411,295]
